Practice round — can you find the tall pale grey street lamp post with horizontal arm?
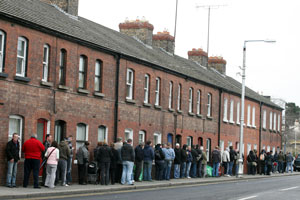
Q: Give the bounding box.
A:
[237,40,276,177]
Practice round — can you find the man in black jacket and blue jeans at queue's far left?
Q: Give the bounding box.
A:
[6,133,20,188]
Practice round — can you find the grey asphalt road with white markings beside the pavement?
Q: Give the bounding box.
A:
[21,176,300,200]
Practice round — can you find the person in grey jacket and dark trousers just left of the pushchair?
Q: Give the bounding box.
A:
[76,142,90,185]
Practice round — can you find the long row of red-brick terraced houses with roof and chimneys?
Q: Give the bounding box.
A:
[0,0,282,183]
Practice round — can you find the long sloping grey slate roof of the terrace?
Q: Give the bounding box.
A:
[0,0,281,109]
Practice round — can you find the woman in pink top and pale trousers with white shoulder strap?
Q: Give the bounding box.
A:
[44,141,59,188]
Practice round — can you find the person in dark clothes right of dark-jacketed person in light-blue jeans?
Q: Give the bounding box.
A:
[134,142,145,182]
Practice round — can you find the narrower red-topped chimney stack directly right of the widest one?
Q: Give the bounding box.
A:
[153,31,175,54]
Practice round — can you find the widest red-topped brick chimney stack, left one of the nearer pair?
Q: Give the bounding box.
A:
[119,19,154,46]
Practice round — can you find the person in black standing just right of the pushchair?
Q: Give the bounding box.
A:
[97,142,113,185]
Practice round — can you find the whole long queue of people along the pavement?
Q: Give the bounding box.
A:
[6,133,294,189]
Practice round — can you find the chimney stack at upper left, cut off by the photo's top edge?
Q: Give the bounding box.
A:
[40,0,79,16]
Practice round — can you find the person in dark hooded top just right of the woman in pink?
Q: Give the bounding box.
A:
[55,138,70,186]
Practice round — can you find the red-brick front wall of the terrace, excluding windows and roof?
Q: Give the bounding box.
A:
[0,2,282,184]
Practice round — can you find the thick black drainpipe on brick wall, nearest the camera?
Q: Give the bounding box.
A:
[114,54,120,142]
